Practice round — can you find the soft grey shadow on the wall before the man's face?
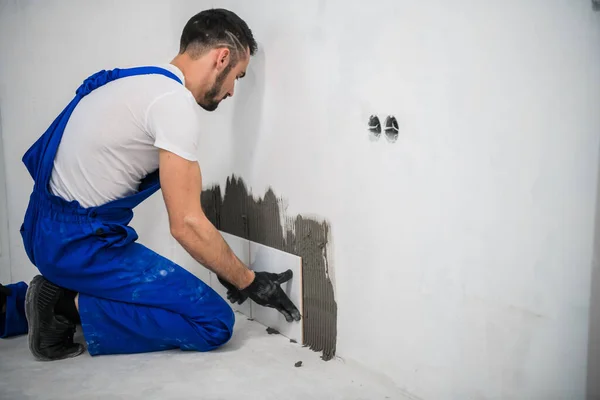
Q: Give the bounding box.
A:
[231,45,265,171]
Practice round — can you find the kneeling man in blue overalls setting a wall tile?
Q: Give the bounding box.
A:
[21,9,300,360]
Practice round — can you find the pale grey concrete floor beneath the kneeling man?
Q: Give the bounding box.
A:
[0,314,410,400]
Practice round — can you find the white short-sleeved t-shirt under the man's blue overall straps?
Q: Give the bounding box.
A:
[50,64,201,207]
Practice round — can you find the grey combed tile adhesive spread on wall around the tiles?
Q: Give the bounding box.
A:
[202,176,337,360]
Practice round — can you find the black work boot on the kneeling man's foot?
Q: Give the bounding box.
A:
[25,275,84,361]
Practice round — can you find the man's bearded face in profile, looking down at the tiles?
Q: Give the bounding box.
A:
[198,48,250,111]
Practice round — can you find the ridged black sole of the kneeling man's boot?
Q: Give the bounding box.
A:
[25,275,84,361]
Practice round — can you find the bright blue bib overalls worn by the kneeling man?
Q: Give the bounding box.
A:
[21,67,234,355]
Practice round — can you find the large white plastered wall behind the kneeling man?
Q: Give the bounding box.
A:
[0,0,600,400]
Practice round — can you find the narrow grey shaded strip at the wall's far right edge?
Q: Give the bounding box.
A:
[586,137,600,400]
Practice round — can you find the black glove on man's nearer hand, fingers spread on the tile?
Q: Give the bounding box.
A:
[240,269,300,322]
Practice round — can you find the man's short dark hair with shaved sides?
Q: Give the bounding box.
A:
[179,8,258,64]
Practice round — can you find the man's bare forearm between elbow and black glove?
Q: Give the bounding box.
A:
[174,215,254,289]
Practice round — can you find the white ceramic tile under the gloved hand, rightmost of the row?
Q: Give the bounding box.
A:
[250,242,302,343]
